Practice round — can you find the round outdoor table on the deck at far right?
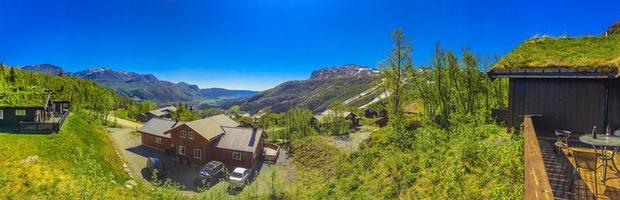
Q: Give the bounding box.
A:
[579,134,620,183]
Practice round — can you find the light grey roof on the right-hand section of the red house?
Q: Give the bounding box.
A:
[215,126,263,152]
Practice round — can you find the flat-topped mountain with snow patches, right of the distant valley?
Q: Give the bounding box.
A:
[241,65,380,113]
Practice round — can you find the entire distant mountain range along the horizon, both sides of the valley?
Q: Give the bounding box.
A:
[22,64,379,113]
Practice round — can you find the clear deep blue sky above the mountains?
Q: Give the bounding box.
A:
[0,0,620,90]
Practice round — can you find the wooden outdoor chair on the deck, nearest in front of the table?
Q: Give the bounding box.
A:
[569,150,604,197]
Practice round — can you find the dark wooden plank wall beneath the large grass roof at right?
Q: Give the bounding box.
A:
[508,79,604,133]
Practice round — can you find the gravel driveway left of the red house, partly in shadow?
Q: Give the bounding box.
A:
[107,128,200,193]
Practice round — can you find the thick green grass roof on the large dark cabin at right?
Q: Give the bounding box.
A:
[493,36,620,71]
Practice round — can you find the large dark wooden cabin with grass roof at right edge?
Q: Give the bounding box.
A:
[488,37,620,133]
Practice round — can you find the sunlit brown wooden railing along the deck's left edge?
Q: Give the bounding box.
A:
[523,116,553,199]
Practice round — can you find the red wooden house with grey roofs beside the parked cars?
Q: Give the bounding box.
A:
[140,115,265,168]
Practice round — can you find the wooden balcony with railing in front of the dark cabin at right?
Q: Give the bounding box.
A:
[523,116,620,199]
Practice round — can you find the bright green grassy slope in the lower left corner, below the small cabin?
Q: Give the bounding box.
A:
[0,113,129,199]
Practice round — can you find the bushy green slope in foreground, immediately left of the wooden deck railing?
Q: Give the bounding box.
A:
[290,119,524,199]
